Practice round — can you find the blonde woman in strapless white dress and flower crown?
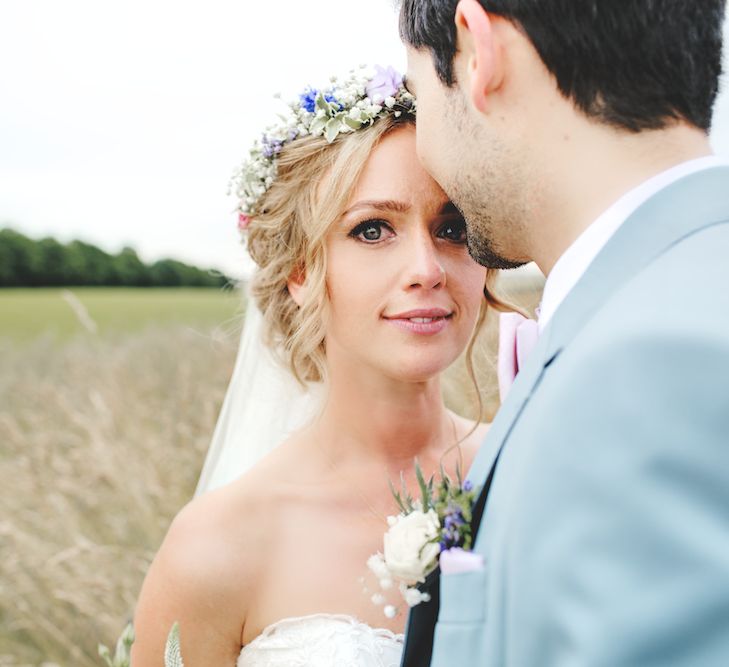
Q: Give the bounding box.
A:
[132,69,506,667]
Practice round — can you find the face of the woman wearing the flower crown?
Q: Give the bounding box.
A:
[326,126,486,381]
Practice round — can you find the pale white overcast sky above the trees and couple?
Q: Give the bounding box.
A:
[0,0,729,276]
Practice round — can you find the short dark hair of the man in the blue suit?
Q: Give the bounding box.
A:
[400,0,726,132]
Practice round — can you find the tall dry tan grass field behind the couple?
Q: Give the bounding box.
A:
[0,276,538,667]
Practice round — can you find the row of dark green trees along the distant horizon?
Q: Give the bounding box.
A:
[0,228,231,287]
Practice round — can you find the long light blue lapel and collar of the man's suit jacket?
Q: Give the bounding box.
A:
[468,167,729,496]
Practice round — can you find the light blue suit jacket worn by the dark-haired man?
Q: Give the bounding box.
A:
[431,167,729,667]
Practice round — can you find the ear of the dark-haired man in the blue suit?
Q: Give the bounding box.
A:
[455,0,503,113]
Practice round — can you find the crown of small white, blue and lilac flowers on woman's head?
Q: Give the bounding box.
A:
[229,65,415,231]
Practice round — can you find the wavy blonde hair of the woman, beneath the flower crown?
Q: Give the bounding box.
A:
[248,115,512,412]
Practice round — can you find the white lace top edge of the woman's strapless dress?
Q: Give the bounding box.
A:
[237,614,403,667]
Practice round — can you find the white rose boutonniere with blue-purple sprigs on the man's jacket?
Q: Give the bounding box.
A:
[367,461,478,618]
